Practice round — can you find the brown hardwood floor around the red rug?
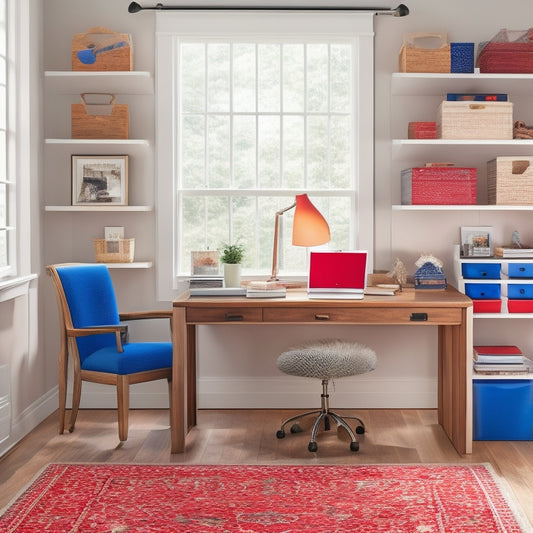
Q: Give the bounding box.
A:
[0,409,533,524]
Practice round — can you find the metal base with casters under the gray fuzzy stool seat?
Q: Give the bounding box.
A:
[276,379,365,452]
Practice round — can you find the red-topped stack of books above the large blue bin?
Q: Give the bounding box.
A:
[474,346,531,375]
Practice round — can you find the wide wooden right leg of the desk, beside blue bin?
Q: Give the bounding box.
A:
[438,309,472,455]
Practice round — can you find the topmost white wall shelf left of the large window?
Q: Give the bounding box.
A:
[44,71,154,94]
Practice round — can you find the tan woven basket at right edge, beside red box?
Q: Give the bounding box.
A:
[487,156,533,205]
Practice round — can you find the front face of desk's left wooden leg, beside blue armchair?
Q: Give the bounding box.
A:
[170,307,188,453]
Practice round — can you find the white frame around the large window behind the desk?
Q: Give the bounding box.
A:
[155,11,374,301]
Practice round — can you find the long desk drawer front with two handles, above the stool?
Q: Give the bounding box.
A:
[263,307,462,324]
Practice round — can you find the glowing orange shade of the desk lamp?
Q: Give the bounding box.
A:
[292,194,331,246]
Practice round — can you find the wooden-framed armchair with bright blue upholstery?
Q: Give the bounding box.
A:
[46,264,172,441]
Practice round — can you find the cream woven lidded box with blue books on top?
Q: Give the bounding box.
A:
[437,101,513,139]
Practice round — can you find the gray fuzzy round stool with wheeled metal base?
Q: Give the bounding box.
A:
[276,339,377,452]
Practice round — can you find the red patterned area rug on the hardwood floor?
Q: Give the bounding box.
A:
[0,464,532,533]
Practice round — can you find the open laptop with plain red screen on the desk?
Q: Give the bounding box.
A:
[307,250,367,300]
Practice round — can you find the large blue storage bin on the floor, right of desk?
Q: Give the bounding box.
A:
[473,379,533,440]
